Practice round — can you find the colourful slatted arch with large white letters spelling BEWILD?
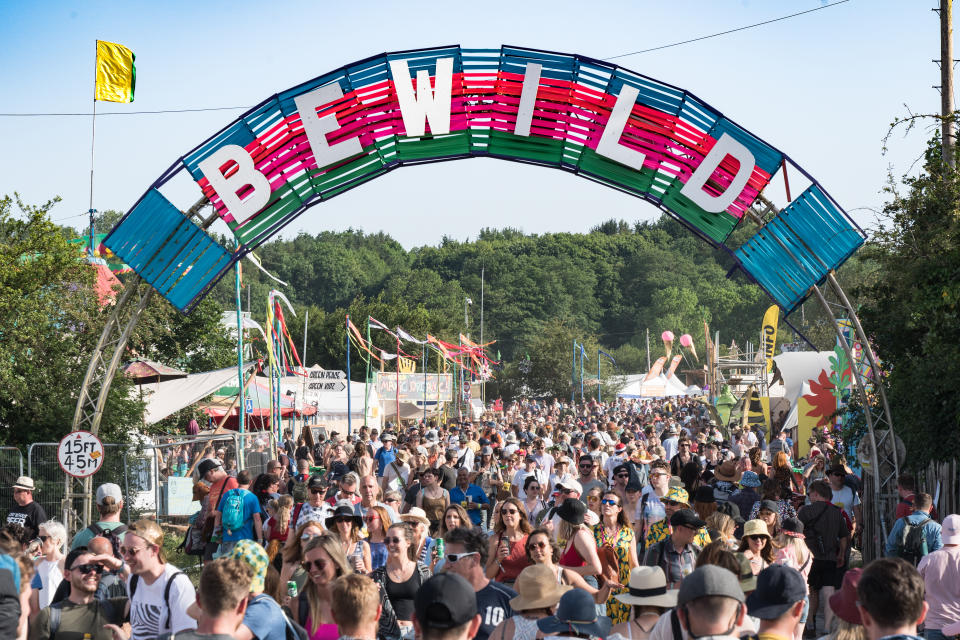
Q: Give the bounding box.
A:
[74,46,892,556]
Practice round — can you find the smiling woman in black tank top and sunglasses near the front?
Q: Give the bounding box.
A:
[370,522,430,640]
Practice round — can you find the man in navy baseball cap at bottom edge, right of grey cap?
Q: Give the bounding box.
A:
[747,564,807,640]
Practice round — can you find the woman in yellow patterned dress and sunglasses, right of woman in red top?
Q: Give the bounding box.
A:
[593,491,640,624]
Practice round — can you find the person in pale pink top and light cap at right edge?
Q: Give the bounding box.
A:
[917,514,960,640]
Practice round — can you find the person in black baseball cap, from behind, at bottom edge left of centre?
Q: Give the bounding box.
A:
[413,572,480,640]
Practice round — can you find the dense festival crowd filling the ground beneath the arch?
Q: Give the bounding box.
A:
[0,399,960,640]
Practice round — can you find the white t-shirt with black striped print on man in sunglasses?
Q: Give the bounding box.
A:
[127,564,197,640]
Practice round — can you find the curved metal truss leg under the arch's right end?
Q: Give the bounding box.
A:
[810,278,897,560]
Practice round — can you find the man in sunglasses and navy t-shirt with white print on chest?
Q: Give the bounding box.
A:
[444,527,517,640]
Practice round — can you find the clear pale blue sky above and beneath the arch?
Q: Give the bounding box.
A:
[0,0,940,247]
